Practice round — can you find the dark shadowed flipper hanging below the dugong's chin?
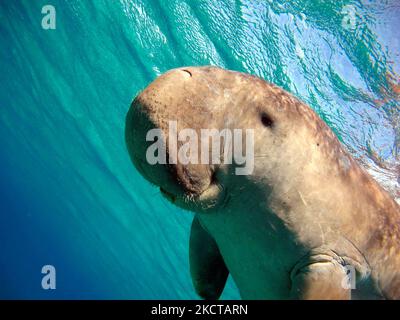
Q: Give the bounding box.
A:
[189,216,229,299]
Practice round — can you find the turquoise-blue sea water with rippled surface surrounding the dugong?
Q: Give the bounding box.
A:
[0,0,400,299]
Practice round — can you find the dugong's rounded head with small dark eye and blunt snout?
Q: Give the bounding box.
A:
[125,67,322,211]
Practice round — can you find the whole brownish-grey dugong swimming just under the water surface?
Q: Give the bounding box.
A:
[126,67,400,299]
